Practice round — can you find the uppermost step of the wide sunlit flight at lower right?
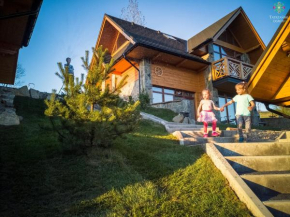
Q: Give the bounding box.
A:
[216,142,290,156]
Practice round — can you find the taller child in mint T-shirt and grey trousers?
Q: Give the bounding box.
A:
[222,81,255,142]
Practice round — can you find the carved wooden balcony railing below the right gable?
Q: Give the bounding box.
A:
[212,57,253,81]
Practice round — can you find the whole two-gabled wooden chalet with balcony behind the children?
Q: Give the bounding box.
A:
[96,7,289,122]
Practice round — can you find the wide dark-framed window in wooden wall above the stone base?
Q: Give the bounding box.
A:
[152,86,194,104]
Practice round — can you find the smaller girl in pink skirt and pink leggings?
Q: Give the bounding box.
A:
[197,89,222,138]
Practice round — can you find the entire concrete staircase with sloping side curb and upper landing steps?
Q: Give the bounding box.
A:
[141,113,290,217]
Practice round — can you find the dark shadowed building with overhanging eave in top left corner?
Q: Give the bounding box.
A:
[0,0,42,84]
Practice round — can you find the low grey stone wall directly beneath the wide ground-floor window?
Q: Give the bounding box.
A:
[151,99,195,119]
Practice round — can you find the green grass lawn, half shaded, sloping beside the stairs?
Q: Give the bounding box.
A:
[0,97,251,217]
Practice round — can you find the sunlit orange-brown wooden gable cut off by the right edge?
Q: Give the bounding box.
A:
[249,10,290,107]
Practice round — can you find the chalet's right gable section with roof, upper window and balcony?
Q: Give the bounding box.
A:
[188,7,265,96]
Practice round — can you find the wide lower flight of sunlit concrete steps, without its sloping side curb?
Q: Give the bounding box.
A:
[215,141,290,217]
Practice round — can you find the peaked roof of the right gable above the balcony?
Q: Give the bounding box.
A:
[188,7,265,52]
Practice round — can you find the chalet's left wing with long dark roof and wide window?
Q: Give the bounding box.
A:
[93,15,210,116]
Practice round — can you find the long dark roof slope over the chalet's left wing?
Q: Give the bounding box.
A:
[101,14,207,63]
